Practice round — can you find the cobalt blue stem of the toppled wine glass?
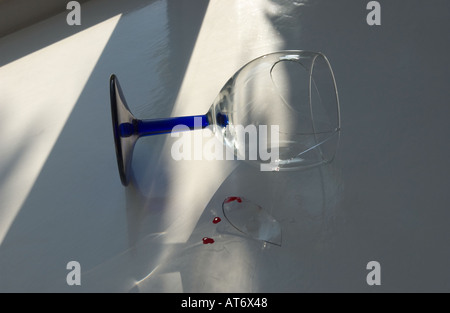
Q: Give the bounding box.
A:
[119,115,209,137]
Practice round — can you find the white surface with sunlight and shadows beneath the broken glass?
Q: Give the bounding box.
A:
[0,0,450,292]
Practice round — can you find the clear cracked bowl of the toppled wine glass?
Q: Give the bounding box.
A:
[211,51,340,171]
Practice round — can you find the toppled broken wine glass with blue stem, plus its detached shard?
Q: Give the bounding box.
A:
[110,50,340,244]
